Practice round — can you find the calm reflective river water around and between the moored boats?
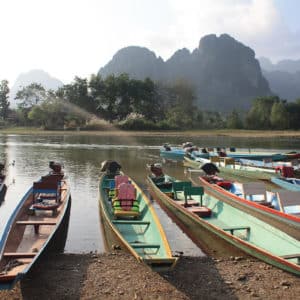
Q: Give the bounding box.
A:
[0,135,300,255]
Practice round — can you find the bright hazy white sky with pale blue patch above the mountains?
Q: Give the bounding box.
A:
[0,0,300,85]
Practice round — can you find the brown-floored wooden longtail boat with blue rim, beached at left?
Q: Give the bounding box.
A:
[0,163,71,289]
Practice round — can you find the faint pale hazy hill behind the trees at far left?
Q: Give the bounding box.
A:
[9,69,64,107]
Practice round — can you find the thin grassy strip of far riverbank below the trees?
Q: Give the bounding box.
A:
[0,127,300,138]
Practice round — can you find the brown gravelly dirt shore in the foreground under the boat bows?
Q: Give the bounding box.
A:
[0,251,300,300]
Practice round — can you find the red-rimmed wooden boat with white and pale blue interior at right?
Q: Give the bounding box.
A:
[195,175,300,240]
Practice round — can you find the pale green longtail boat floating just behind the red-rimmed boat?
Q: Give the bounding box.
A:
[183,155,279,180]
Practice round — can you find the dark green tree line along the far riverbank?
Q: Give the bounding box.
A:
[0,74,300,130]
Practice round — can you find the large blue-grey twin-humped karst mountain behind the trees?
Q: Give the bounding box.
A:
[99,34,271,111]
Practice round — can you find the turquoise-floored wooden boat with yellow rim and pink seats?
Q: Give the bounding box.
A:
[99,162,177,271]
